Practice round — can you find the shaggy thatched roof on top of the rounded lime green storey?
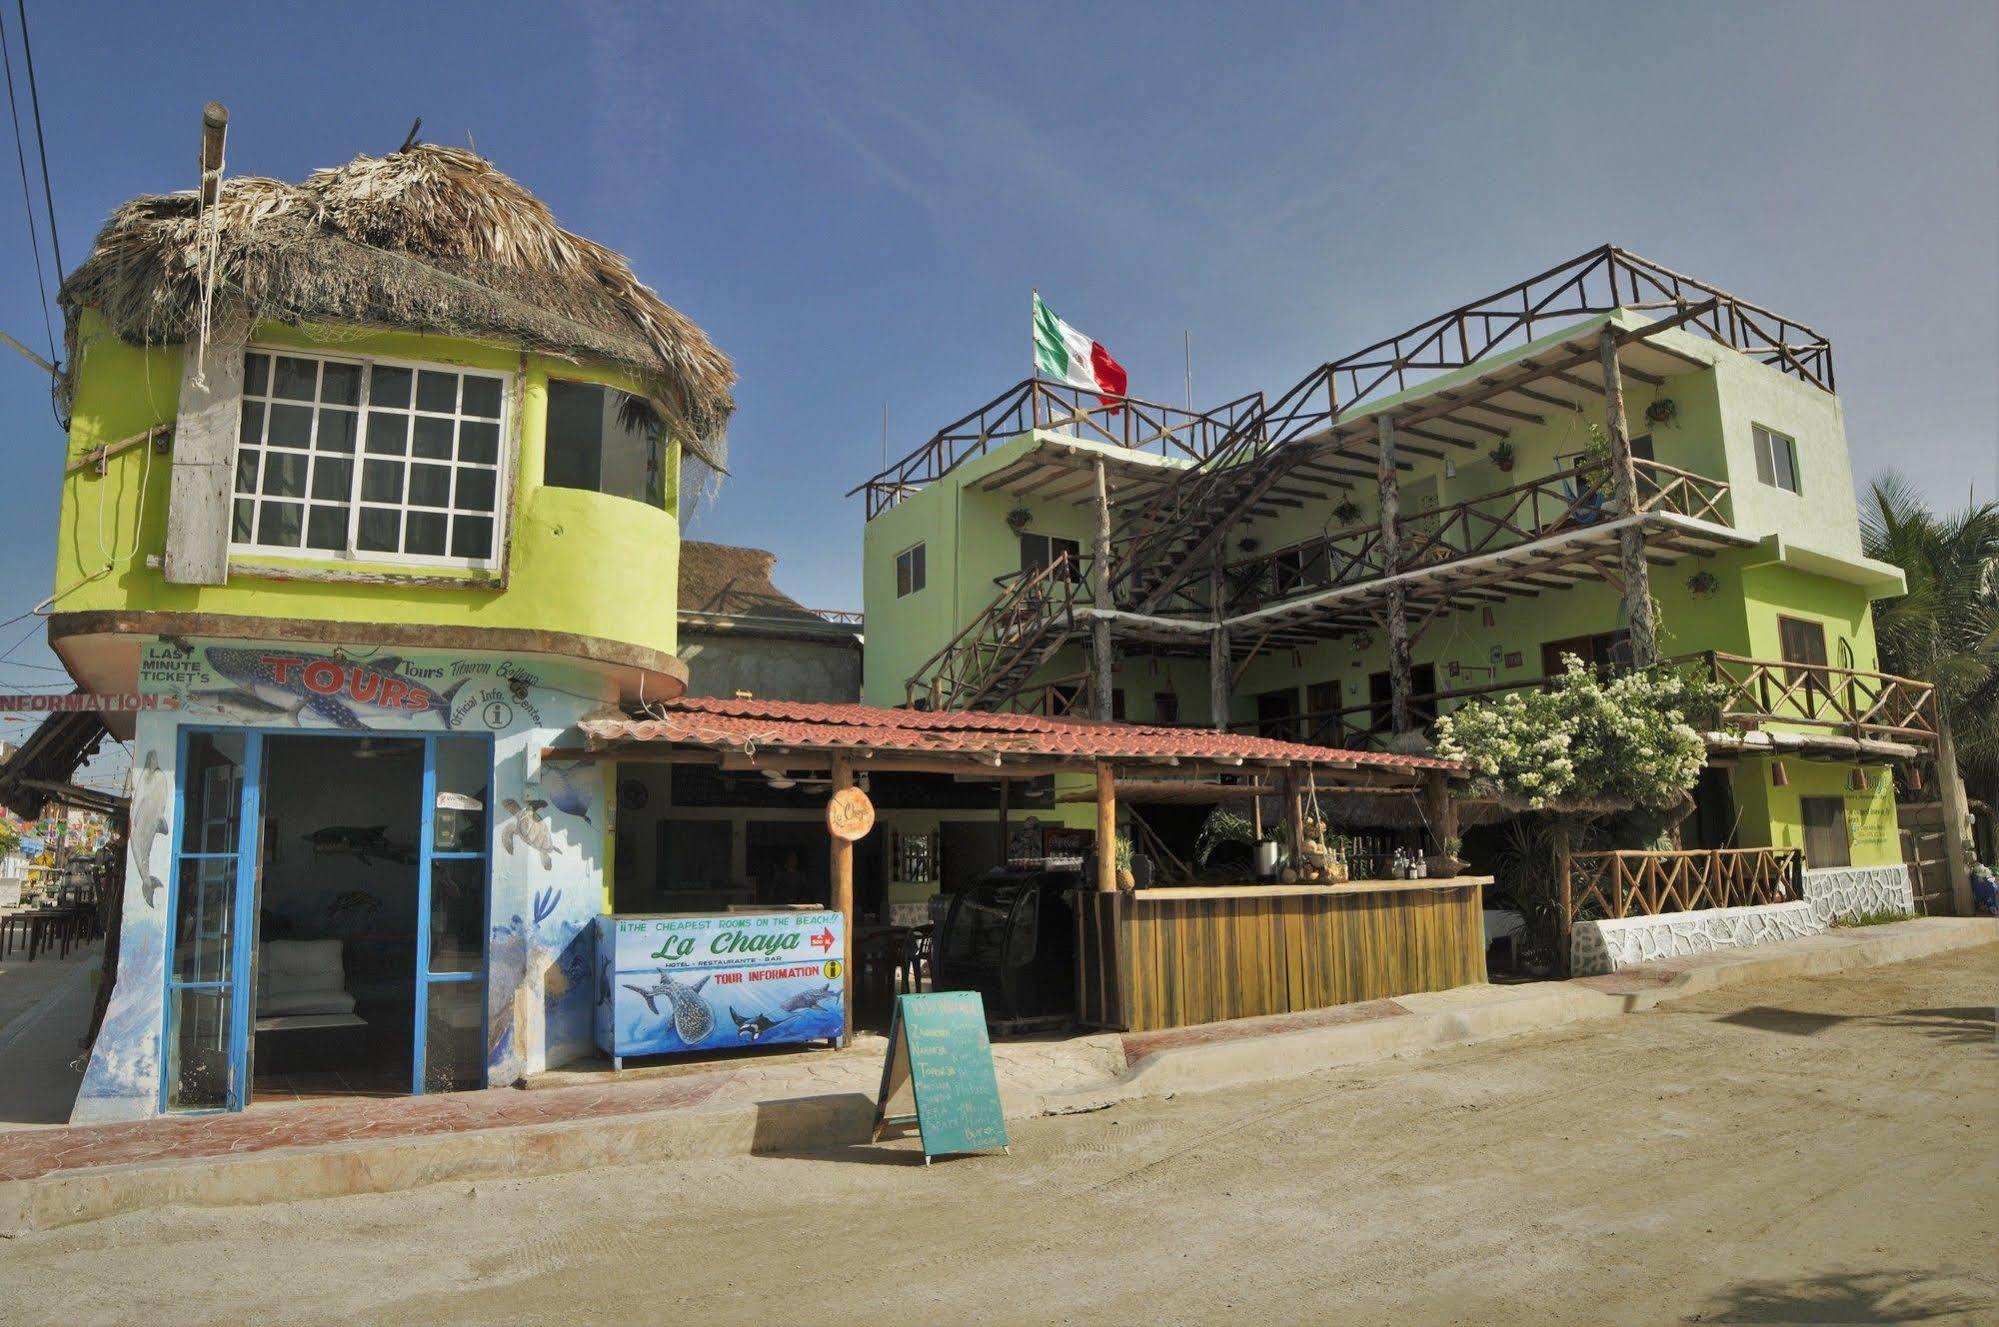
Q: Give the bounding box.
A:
[62,144,736,470]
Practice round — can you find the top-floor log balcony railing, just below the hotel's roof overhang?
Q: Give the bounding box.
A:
[1229,458,1729,612]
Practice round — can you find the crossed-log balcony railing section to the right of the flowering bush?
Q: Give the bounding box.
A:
[1667,650,1937,743]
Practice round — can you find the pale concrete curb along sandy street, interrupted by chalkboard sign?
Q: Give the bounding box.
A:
[0,917,1999,1237]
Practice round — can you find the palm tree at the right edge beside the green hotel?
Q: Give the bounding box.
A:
[1861,474,1999,913]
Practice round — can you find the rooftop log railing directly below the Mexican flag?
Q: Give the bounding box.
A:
[848,378,1263,520]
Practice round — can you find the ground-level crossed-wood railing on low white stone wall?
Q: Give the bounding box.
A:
[1555,847,1805,925]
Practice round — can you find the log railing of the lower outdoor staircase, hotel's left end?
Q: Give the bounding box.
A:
[904,554,1089,709]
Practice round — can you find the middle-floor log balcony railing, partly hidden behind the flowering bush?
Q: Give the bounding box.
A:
[1255,650,1937,749]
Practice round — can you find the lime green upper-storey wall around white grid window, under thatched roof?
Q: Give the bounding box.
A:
[56,314,680,652]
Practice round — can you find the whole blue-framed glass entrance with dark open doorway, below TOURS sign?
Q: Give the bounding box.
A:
[159,727,494,1111]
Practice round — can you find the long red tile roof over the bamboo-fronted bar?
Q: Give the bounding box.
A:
[580,697,1463,771]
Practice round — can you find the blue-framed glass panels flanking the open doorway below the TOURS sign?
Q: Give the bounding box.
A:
[160,727,494,1113]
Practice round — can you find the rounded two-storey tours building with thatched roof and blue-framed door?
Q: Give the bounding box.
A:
[50,134,734,1121]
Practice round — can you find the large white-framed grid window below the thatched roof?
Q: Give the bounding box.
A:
[230,348,508,568]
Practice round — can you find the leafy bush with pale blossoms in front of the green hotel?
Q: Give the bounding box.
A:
[1437,656,1721,811]
